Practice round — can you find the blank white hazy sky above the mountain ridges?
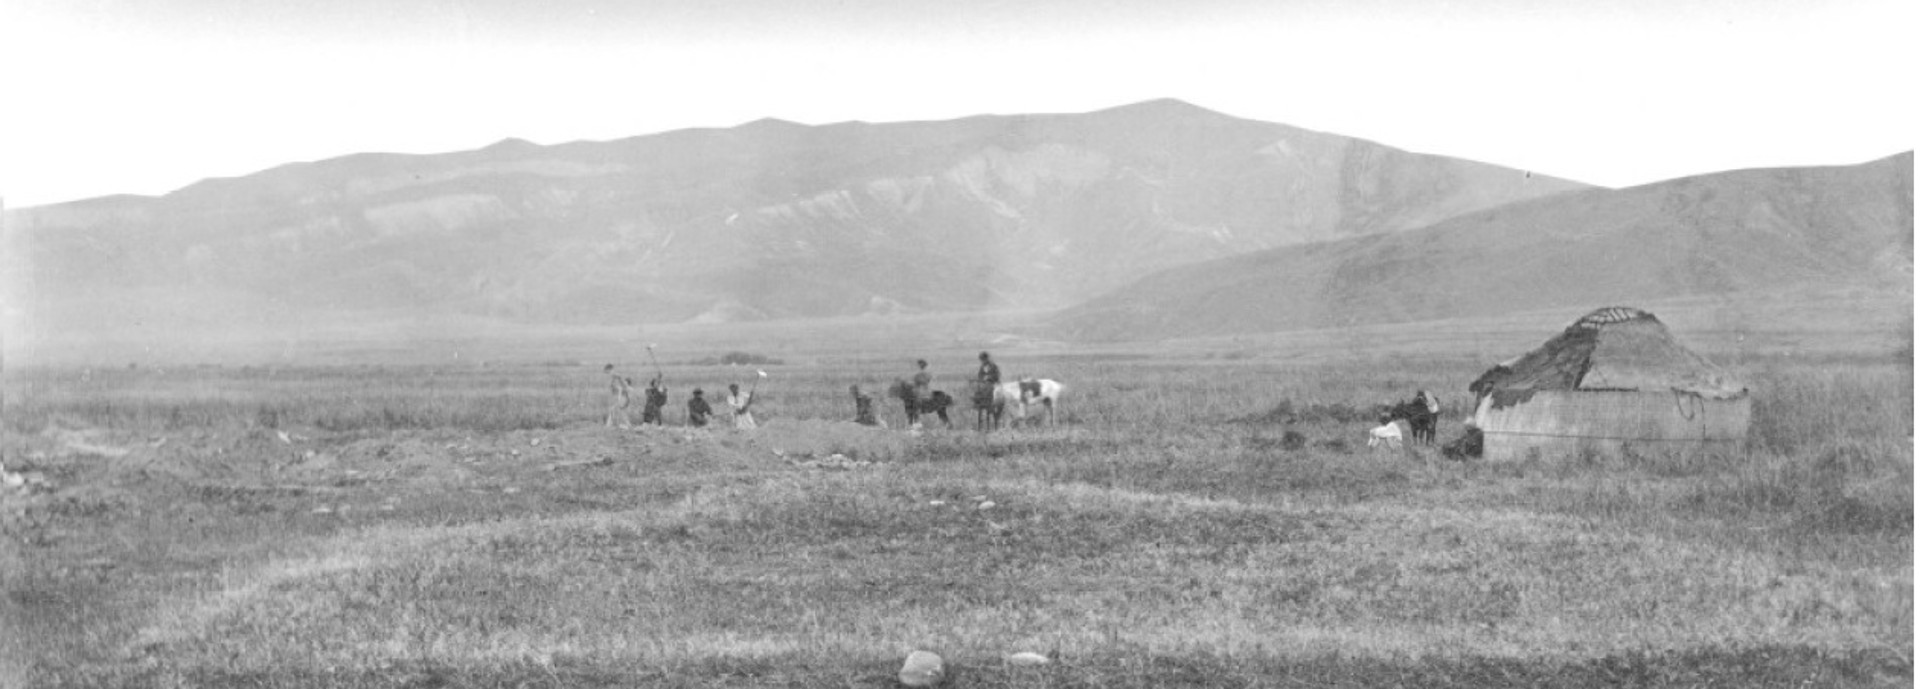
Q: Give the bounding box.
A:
[0,0,1920,207]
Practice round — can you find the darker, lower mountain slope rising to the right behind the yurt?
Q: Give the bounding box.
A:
[1056,152,1914,340]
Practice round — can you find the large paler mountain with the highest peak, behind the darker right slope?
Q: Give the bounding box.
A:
[6,100,1584,330]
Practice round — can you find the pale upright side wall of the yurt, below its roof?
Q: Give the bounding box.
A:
[1476,390,1753,461]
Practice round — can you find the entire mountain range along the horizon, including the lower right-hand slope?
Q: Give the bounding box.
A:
[0,100,1912,358]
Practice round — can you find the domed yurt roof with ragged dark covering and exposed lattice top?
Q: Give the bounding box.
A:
[1473,307,1747,399]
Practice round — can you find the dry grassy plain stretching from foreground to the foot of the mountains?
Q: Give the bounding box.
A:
[0,324,1914,687]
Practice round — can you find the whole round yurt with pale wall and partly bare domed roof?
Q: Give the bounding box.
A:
[1469,307,1753,461]
